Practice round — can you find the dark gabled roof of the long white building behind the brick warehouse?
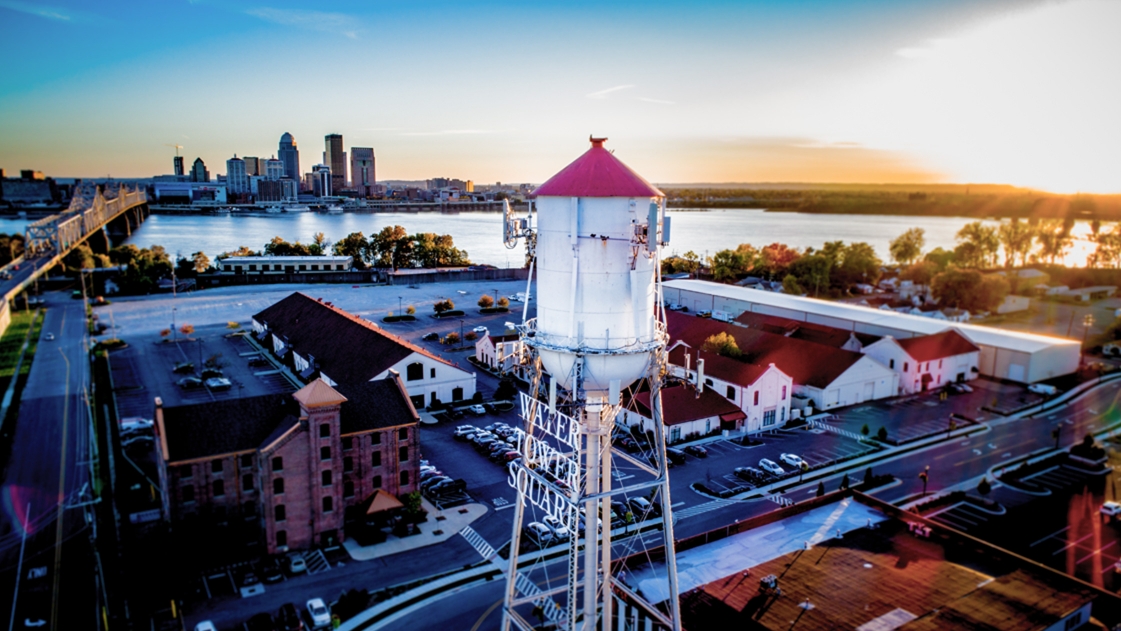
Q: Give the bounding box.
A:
[253,293,463,383]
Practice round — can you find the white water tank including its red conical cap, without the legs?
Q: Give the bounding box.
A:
[534,138,665,397]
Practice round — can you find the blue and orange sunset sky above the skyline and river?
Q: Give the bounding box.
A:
[0,0,1121,193]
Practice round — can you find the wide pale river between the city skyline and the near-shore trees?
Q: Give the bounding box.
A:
[0,208,1094,267]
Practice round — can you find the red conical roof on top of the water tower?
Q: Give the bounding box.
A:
[534,138,666,197]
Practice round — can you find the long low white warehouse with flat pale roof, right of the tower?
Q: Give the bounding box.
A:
[664,280,1081,383]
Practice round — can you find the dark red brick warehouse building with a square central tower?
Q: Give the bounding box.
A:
[156,373,420,554]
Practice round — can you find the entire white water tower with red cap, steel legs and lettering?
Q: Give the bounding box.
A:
[503,138,680,631]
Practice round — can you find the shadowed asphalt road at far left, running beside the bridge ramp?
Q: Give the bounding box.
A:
[0,294,92,628]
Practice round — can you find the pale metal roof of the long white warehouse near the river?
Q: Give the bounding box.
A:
[664,280,1078,353]
